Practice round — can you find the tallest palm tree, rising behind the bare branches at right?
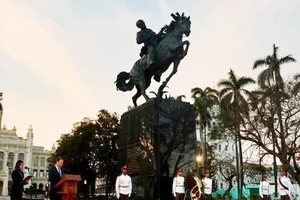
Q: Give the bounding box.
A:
[253,44,296,196]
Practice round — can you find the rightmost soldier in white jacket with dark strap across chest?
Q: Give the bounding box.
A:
[278,168,292,200]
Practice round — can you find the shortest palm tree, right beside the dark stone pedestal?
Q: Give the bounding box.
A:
[191,87,218,168]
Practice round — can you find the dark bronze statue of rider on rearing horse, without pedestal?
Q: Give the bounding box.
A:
[115,13,191,106]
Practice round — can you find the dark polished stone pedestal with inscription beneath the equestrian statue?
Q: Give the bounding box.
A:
[118,98,196,200]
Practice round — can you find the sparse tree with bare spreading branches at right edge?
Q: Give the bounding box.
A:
[241,79,300,184]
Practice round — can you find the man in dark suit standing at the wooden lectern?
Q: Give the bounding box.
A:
[49,157,64,200]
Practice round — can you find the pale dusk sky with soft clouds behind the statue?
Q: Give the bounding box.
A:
[0,0,300,149]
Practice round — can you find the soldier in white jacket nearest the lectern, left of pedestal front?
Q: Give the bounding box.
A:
[116,165,132,200]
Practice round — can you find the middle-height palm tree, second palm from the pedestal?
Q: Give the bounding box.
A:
[218,70,255,199]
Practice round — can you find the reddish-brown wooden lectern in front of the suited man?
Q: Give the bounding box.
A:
[54,174,81,200]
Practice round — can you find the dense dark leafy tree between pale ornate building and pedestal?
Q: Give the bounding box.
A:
[53,110,120,195]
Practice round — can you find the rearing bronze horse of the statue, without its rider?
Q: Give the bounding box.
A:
[115,13,191,107]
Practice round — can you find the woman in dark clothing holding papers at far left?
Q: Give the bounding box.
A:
[10,160,27,200]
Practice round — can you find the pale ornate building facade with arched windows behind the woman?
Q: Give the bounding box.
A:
[0,93,55,195]
